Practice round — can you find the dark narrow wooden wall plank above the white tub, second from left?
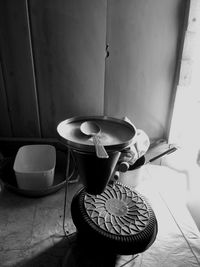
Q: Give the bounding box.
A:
[0,0,40,137]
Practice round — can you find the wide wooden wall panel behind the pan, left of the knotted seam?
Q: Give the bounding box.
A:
[29,0,106,137]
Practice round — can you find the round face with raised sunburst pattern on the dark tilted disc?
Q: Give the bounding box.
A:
[84,183,149,235]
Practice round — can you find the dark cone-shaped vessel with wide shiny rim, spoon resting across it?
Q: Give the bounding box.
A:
[57,116,136,195]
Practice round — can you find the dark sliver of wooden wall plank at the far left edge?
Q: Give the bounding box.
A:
[0,61,12,136]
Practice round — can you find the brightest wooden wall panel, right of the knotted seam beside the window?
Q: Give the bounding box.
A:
[105,0,182,140]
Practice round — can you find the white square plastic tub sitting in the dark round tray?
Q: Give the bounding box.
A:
[13,145,56,190]
